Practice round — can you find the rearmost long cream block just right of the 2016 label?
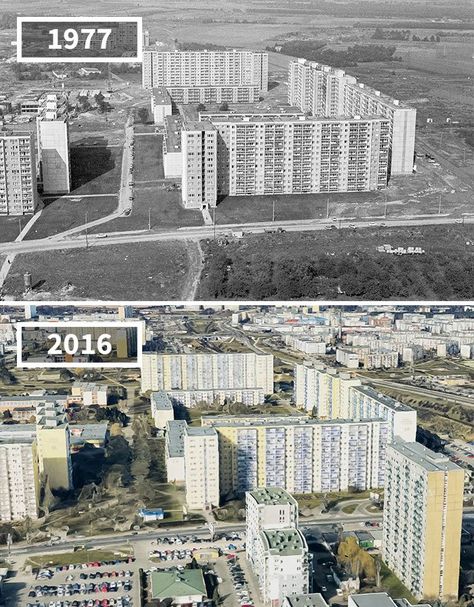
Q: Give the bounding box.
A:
[141,352,273,394]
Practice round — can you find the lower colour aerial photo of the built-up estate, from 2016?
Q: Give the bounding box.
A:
[0,304,474,607]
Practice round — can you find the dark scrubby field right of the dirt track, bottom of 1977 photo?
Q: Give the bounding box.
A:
[197,225,474,300]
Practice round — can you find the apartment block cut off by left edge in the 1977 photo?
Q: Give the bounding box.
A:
[0,131,37,215]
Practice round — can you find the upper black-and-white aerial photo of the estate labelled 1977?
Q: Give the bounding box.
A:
[0,0,474,301]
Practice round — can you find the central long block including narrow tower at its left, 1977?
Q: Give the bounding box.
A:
[177,114,390,209]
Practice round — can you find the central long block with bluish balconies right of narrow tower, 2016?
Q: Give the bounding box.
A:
[202,415,388,498]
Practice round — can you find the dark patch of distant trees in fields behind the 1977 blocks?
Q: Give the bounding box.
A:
[267,41,400,67]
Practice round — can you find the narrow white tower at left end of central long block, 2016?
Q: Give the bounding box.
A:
[184,426,219,510]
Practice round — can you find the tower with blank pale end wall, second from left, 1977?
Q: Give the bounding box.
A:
[36,94,71,194]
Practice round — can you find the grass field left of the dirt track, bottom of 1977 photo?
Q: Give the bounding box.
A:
[3,242,190,300]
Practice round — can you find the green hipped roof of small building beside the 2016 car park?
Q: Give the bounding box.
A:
[151,569,207,599]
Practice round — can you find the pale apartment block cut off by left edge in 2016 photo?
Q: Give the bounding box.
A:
[0,438,39,522]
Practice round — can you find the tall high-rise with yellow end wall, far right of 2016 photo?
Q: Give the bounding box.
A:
[382,442,464,600]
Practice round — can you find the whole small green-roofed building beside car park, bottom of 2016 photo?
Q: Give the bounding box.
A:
[150,569,207,605]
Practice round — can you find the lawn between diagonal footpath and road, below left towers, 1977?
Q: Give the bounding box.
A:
[25,196,118,240]
